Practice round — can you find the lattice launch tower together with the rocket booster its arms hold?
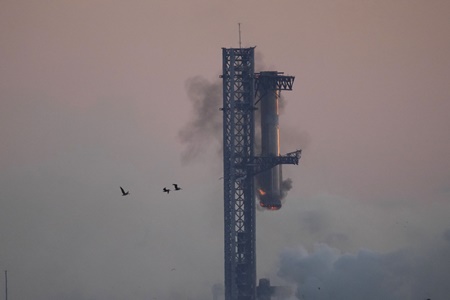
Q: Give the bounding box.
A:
[221,47,301,300]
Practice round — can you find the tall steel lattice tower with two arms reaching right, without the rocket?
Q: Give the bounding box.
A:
[221,47,301,300]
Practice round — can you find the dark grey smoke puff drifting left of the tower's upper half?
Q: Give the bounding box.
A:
[178,76,222,163]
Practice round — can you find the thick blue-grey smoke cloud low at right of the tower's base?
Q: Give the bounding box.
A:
[278,239,450,300]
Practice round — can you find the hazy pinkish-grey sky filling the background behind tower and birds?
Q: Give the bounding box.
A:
[0,0,450,300]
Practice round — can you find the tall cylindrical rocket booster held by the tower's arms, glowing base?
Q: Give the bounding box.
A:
[257,72,282,210]
